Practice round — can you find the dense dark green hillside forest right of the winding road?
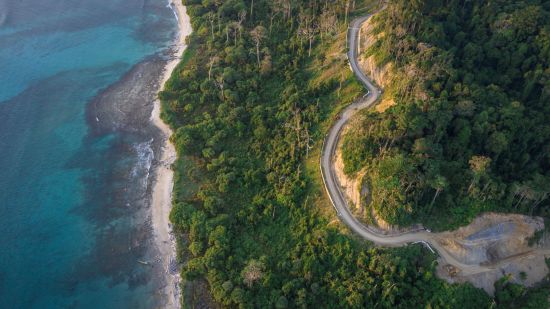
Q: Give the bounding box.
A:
[343,0,550,229]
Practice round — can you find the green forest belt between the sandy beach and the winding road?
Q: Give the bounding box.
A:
[161,0,548,308]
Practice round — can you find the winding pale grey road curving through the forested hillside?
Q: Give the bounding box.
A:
[321,15,493,274]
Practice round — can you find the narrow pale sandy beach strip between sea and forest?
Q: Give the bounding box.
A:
[151,0,192,308]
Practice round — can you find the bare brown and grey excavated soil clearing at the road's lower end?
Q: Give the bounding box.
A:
[434,213,550,294]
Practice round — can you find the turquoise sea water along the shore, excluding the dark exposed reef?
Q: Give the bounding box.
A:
[0,0,176,308]
